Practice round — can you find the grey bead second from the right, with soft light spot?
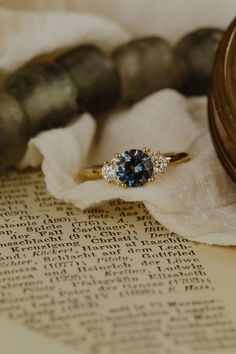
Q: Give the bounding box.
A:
[113,37,177,104]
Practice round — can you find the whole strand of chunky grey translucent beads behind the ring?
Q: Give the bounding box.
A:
[0,28,223,170]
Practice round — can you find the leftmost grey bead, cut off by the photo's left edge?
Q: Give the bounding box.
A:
[0,92,29,170]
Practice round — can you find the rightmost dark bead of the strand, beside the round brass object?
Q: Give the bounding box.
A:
[176,28,223,95]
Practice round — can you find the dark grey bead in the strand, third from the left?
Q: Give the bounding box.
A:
[57,45,120,114]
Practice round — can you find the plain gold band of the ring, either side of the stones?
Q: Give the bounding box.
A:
[78,152,190,182]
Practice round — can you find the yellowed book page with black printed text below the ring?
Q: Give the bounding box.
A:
[0,171,236,354]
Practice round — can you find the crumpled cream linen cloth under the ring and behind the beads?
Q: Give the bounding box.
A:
[0,0,236,245]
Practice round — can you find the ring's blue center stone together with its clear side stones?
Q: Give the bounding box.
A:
[101,149,170,187]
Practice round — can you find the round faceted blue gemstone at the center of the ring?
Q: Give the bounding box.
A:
[115,149,153,187]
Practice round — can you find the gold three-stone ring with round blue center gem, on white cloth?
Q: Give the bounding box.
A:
[79,148,190,187]
